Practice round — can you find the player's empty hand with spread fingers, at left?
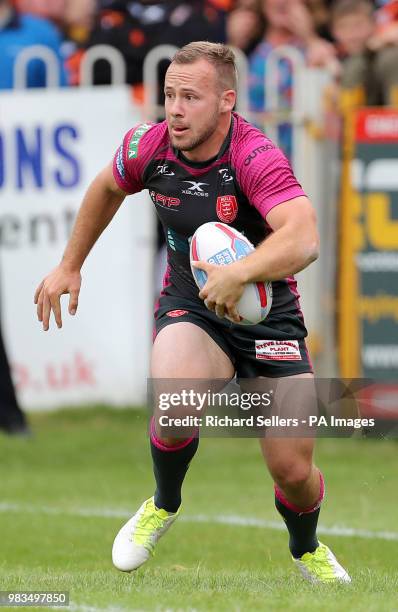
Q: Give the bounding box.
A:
[35,263,82,331]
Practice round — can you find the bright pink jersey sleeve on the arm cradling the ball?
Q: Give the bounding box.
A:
[234,130,306,218]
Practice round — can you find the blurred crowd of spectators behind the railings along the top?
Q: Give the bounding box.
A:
[0,0,398,109]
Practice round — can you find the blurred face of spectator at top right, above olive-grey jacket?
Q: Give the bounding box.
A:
[333,12,375,55]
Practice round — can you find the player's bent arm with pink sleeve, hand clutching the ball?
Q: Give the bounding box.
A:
[196,137,319,321]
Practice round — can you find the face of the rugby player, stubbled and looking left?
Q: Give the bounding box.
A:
[164,59,221,151]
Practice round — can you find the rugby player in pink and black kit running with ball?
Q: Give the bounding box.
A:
[35,42,350,582]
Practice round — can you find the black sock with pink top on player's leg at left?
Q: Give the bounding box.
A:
[151,436,199,512]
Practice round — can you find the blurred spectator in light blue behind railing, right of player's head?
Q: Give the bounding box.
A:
[249,0,336,157]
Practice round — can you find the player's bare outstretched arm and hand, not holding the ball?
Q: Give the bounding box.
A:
[35,164,127,331]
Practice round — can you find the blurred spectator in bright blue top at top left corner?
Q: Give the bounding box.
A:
[0,0,67,89]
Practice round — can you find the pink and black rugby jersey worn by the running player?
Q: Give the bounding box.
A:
[113,113,305,314]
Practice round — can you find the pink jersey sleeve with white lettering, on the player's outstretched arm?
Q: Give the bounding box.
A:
[113,123,152,193]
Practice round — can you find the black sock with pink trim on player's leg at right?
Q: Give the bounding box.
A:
[275,474,324,559]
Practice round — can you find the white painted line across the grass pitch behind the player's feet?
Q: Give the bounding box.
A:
[0,502,398,541]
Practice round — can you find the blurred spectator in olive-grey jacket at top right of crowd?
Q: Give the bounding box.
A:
[332,0,398,106]
